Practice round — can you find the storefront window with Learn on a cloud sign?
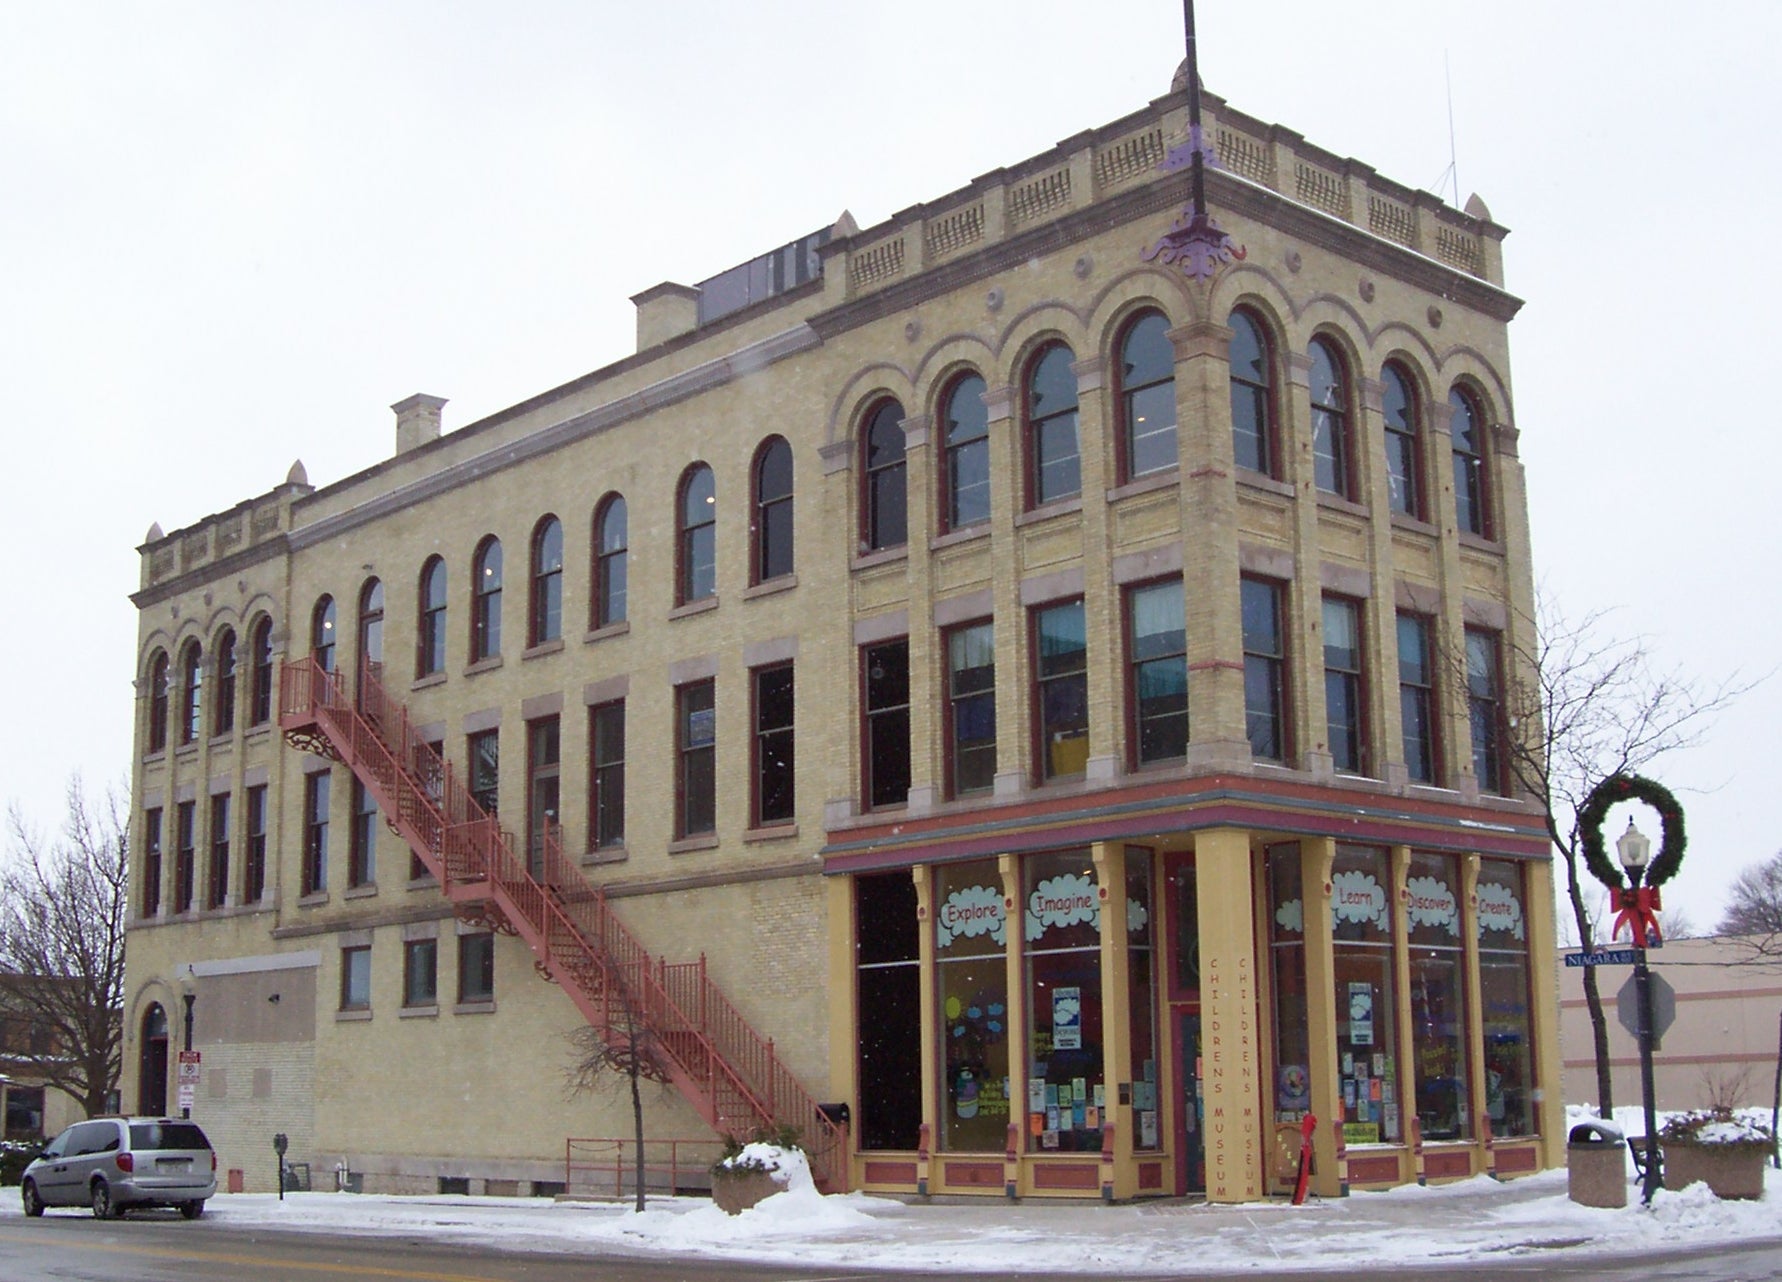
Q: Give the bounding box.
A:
[1331,845,1404,1145]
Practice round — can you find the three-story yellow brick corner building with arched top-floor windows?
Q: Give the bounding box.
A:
[125,72,1563,1202]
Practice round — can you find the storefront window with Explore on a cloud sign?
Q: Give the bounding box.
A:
[934,859,1009,1154]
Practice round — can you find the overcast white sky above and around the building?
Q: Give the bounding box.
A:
[0,0,1782,927]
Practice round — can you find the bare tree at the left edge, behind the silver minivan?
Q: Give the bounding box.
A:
[0,776,130,1116]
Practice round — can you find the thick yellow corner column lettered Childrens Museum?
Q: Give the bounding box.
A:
[1194,827,1263,1202]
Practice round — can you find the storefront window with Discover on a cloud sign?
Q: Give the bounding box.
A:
[1404,854,1472,1139]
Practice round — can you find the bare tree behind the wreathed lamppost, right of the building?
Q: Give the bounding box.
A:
[1504,597,1753,1116]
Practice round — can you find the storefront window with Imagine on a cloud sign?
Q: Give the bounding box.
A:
[1025,851,1107,1152]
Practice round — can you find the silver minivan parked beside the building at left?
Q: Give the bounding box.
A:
[20,1118,217,1220]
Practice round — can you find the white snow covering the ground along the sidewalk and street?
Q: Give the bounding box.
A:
[0,1109,1782,1277]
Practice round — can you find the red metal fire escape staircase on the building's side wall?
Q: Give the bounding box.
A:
[278,658,846,1189]
